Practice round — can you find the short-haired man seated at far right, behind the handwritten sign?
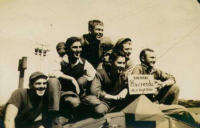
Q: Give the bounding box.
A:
[132,48,179,104]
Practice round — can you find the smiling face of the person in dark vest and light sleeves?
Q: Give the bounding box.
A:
[70,41,82,59]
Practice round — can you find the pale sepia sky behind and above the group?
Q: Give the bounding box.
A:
[0,0,200,104]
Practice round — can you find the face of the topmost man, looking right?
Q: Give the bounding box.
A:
[91,24,104,40]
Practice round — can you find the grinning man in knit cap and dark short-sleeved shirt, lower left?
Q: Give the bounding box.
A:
[4,72,47,128]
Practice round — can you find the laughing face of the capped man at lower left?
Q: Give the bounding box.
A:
[33,78,47,96]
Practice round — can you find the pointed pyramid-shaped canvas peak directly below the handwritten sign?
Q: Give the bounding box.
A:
[122,95,173,128]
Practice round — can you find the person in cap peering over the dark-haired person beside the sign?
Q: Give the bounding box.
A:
[113,38,134,73]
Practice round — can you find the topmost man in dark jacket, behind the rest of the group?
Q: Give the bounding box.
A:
[81,20,113,69]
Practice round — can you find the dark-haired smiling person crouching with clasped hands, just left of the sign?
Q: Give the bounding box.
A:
[88,52,128,114]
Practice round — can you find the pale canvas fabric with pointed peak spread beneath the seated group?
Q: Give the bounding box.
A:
[61,95,198,128]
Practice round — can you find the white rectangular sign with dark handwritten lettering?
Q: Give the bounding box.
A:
[128,74,156,95]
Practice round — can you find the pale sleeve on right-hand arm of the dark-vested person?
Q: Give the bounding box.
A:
[83,60,96,81]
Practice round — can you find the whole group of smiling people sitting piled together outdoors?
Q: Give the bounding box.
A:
[0,20,179,128]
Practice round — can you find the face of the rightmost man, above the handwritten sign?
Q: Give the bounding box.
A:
[145,51,156,68]
